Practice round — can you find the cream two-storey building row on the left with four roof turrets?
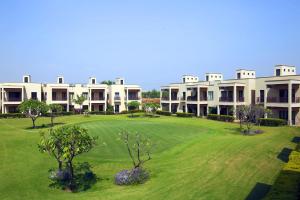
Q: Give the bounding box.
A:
[0,75,142,113]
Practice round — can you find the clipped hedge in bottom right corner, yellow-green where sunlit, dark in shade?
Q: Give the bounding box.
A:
[266,151,300,199]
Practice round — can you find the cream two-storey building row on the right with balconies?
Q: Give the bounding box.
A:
[161,65,300,125]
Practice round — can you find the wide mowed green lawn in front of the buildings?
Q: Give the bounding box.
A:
[0,116,300,200]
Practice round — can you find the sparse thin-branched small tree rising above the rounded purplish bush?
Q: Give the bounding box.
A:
[120,132,153,168]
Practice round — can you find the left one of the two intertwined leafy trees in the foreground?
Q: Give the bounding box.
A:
[38,128,64,171]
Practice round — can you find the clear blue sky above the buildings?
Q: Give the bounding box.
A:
[0,0,300,90]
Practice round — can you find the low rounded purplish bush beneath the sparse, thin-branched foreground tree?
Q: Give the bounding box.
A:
[115,167,149,185]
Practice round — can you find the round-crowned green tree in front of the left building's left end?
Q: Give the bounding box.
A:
[19,99,48,128]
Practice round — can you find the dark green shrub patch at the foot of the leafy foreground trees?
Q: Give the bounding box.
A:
[49,162,100,192]
